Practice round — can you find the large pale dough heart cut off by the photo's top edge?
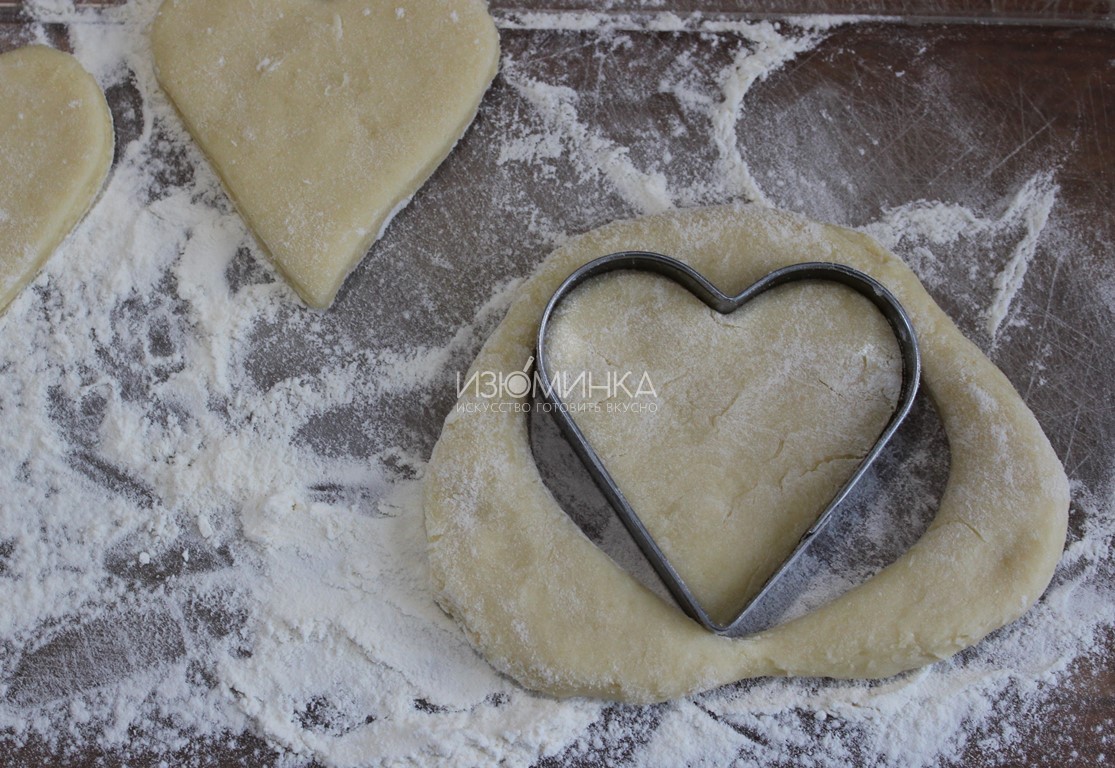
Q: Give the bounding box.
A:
[152,0,500,308]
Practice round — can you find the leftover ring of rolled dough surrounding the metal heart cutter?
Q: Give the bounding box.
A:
[425,207,1068,702]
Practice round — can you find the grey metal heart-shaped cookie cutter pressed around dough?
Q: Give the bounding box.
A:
[534,251,921,634]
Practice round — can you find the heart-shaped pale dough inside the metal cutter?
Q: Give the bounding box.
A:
[547,266,902,625]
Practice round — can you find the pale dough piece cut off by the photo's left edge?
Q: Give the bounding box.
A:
[0,46,114,312]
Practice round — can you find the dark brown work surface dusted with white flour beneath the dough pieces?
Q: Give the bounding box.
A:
[0,2,1115,766]
